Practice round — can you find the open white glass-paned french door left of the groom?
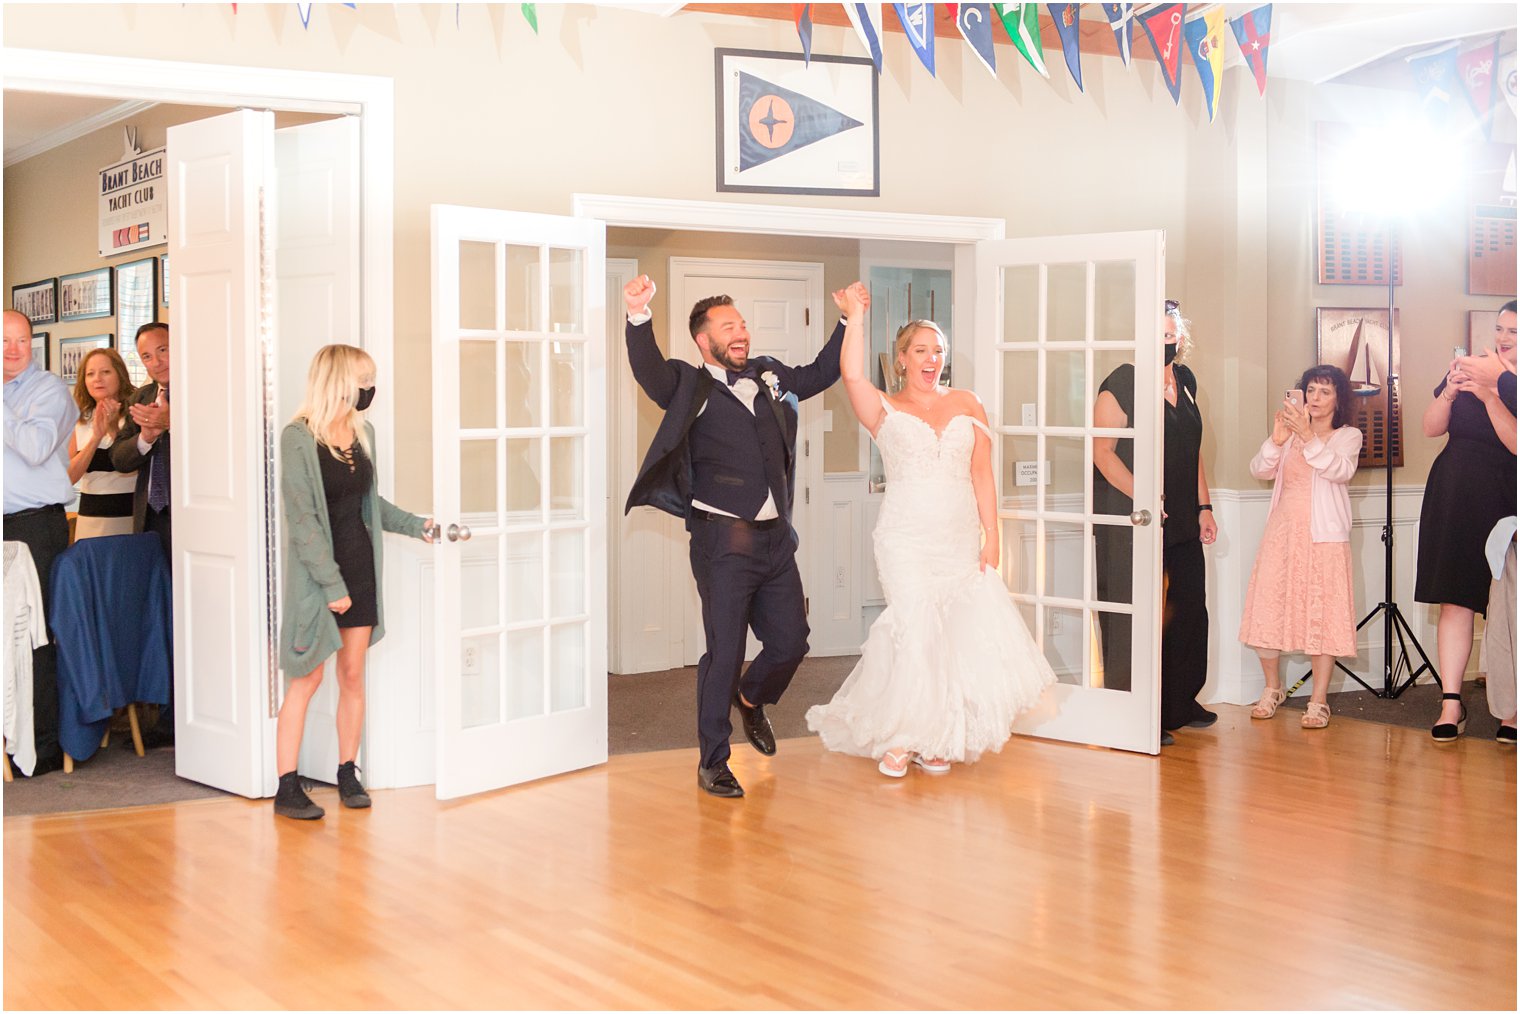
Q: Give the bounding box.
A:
[433,205,608,800]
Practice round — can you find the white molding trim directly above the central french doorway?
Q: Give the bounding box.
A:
[570,193,1006,243]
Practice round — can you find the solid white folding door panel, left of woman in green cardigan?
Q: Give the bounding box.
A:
[169,109,278,797]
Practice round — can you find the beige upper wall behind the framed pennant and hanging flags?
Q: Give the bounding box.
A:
[3,5,1514,509]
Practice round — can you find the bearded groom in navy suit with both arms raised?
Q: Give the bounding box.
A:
[623,275,845,798]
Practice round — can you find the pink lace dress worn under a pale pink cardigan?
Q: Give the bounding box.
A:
[1240,438,1356,657]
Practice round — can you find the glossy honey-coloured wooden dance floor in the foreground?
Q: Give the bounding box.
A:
[5,707,1515,1009]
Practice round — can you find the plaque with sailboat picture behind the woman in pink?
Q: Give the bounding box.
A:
[1315,307,1398,467]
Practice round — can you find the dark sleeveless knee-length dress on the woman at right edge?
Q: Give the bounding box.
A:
[1415,380,1515,616]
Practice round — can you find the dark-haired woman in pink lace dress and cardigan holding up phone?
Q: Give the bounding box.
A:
[1240,366,1362,728]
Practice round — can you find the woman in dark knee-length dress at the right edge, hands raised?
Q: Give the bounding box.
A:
[1415,299,1515,743]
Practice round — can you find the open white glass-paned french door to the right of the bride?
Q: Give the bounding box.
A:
[976,231,1166,754]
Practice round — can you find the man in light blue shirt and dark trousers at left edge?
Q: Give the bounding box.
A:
[5,310,79,777]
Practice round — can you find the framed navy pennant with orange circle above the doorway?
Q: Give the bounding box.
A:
[714,49,882,198]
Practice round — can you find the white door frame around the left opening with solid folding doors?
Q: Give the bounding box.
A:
[0,47,406,794]
